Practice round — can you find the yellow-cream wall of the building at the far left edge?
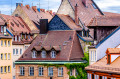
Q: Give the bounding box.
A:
[0,39,12,79]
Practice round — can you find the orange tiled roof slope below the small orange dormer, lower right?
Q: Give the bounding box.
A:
[85,56,120,74]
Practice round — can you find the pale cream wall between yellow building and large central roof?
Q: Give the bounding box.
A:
[12,44,30,76]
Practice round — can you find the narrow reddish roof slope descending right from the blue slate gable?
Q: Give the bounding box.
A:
[57,14,82,30]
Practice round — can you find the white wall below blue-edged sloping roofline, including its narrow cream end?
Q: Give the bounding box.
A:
[89,28,120,65]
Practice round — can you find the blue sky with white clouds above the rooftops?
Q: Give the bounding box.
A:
[0,0,120,15]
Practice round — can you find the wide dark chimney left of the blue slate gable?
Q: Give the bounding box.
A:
[40,19,48,34]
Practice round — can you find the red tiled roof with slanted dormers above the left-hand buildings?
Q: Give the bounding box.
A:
[0,14,30,34]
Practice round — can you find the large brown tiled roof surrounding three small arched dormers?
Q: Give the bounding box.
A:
[18,31,84,61]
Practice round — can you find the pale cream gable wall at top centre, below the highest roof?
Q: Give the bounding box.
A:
[57,0,75,19]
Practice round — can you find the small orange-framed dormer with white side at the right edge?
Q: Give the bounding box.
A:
[106,48,120,64]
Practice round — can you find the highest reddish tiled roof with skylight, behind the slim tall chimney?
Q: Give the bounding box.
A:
[69,0,103,26]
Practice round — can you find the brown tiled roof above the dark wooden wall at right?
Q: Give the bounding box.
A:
[88,15,120,27]
